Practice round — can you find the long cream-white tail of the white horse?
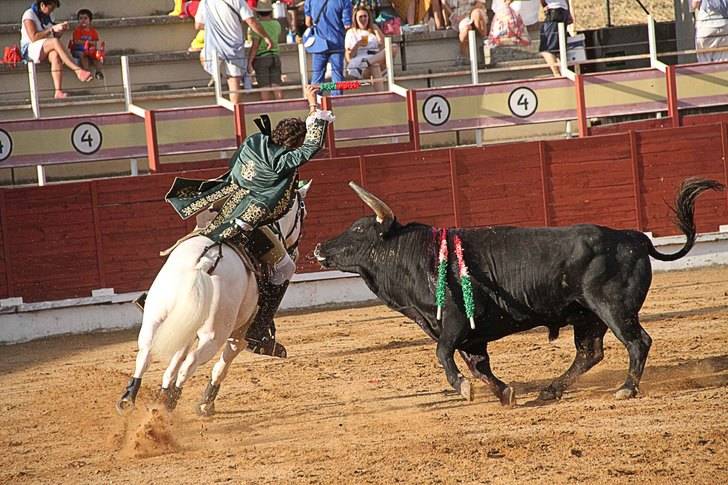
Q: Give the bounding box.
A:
[152,264,213,360]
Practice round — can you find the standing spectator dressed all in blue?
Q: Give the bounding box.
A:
[304,0,351,96]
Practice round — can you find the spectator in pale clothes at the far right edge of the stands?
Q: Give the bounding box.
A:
[692,0,728,62]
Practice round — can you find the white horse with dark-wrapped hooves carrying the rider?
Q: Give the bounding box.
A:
[116,182,311,415]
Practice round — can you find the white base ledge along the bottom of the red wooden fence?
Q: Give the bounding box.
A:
[0,231,728,344]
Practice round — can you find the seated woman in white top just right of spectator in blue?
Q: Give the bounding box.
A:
[344,5,396,91]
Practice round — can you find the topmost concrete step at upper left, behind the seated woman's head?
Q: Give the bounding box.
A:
[0,0,173,24]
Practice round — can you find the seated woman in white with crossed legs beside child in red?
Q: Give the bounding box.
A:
[20,0,93,98]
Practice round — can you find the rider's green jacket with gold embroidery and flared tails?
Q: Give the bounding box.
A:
[165,114,328,242]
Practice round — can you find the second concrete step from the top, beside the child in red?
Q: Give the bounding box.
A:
[0,15,196,54]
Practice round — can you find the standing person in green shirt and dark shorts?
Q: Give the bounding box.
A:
[248,0,283,101]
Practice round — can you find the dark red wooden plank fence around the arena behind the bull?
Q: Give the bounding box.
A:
[0,123,728,301]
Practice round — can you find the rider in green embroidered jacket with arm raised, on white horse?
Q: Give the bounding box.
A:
[165,86,334,357]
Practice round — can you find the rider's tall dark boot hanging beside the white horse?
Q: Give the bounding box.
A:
[245,281,288,358]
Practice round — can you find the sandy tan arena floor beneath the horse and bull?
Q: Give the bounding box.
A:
[0,267,728,484]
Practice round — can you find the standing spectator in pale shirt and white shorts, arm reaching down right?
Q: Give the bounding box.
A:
[195,0,273,104]
